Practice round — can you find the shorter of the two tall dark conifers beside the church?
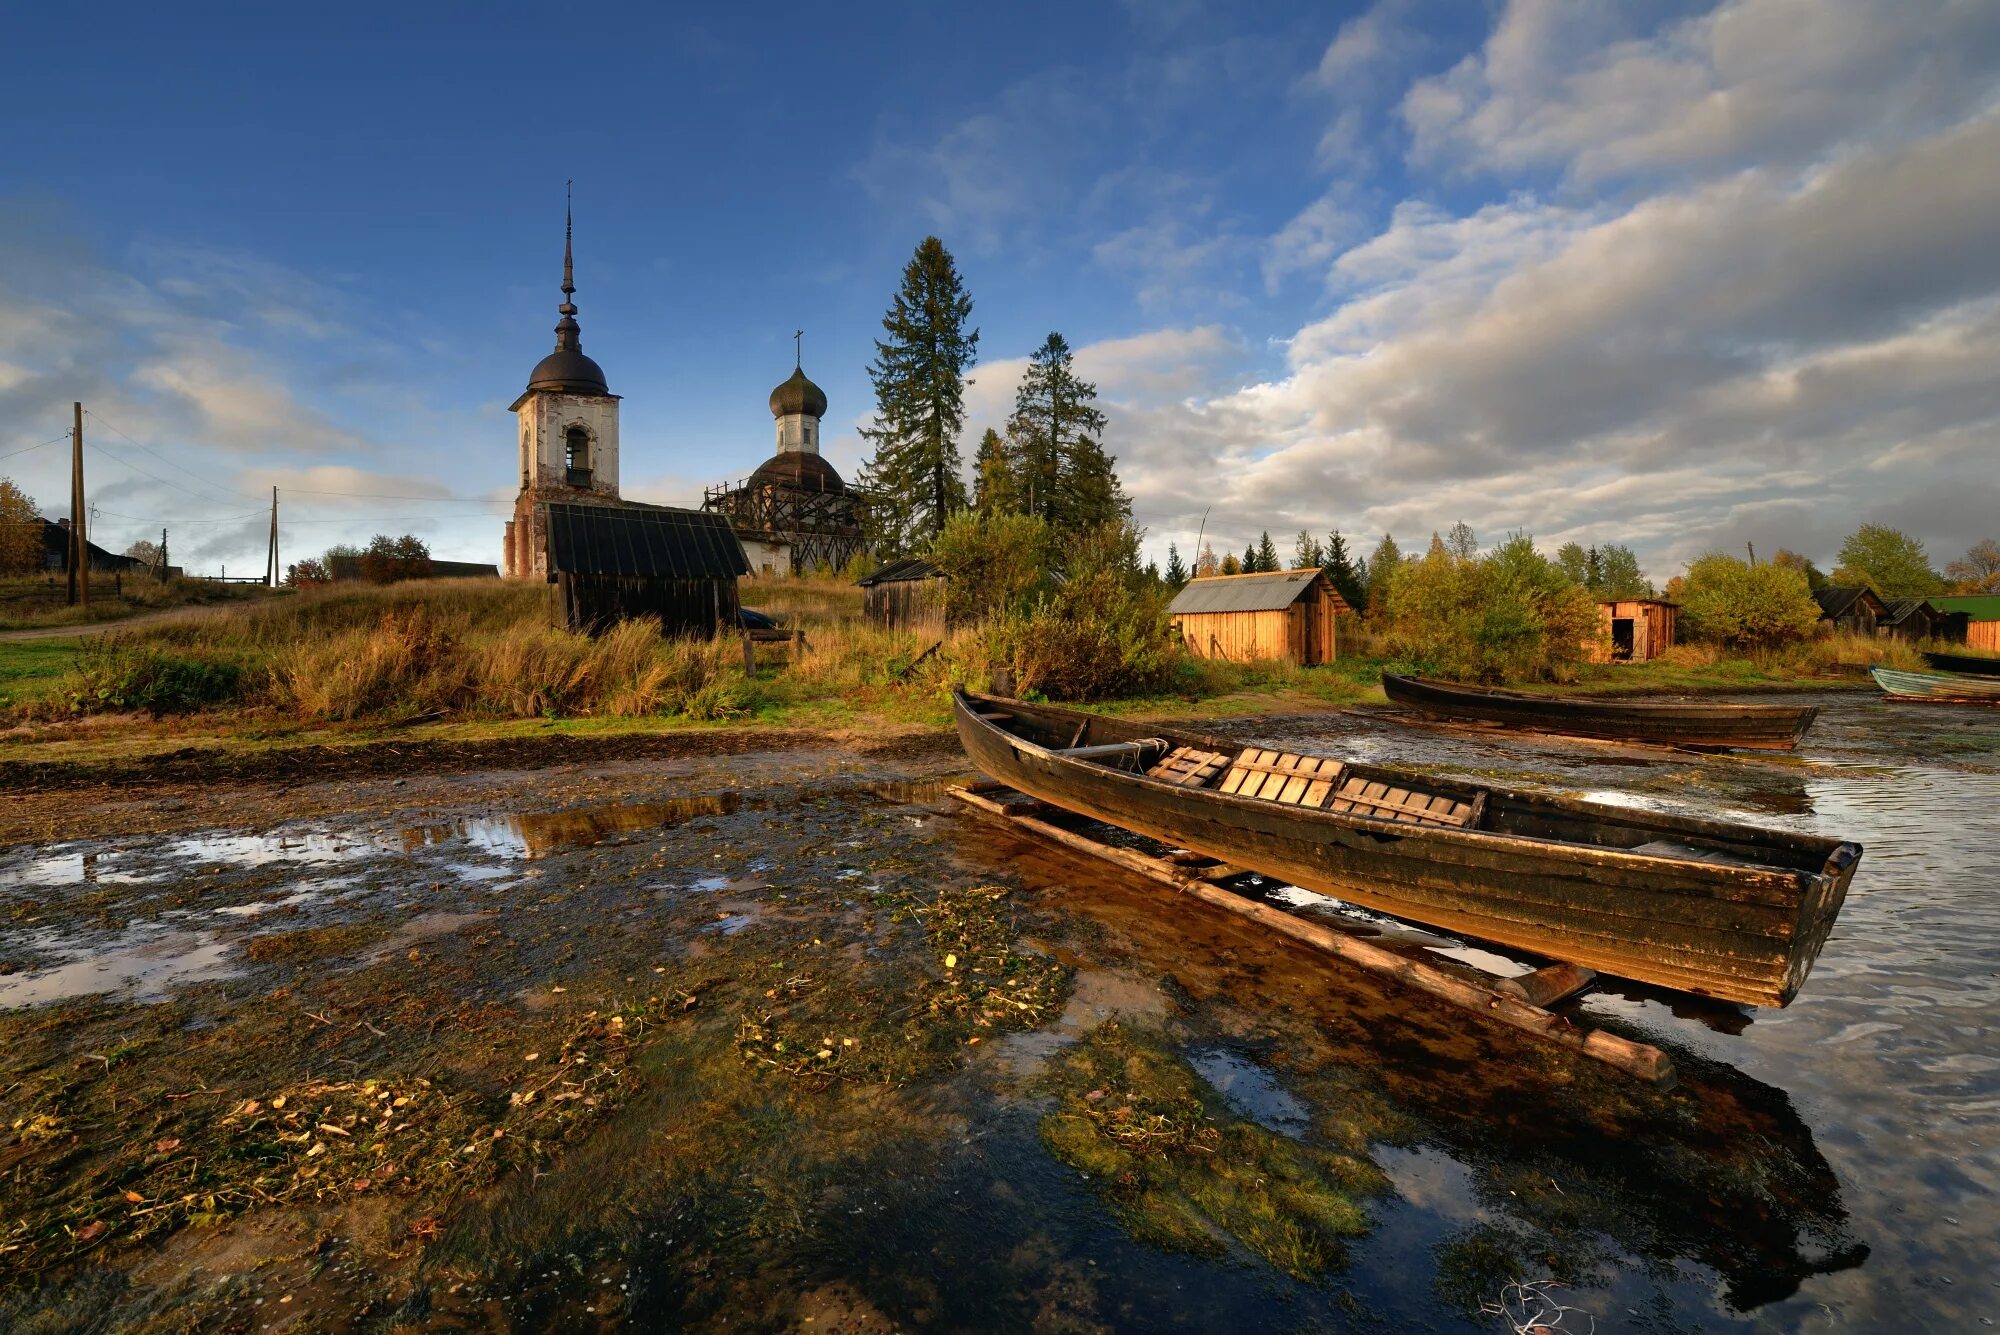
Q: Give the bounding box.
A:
[1006,334,1132,532]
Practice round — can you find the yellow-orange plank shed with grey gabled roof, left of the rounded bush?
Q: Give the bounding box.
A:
[1168,568,1350,668]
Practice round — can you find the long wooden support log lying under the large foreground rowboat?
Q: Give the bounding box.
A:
[950,787,1674,1085]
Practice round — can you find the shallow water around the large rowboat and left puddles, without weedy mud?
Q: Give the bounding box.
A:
[0,695,2000,1331]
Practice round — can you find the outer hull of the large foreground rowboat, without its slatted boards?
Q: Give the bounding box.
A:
[956,695,1860,1005]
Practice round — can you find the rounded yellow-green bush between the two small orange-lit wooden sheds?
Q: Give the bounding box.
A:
[1384,534,1598,681]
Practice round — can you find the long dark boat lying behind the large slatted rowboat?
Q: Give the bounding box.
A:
[1382,671,1820,751]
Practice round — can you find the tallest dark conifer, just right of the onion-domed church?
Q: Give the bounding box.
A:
[862,236,980,556]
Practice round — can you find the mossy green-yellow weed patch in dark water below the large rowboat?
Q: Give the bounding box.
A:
[1042,1021,1386,1279]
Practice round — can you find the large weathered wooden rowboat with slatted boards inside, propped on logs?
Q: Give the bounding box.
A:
[952,691,1862,1005]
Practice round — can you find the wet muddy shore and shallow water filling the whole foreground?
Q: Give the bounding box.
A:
[0,701,2000,1331]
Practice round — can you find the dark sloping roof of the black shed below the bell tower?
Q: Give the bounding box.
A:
[540,502,750,580]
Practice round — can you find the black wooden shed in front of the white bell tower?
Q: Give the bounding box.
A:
[540,502,750,636]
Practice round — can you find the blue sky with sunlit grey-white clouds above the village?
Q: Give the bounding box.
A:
[0,0,2000,582]
